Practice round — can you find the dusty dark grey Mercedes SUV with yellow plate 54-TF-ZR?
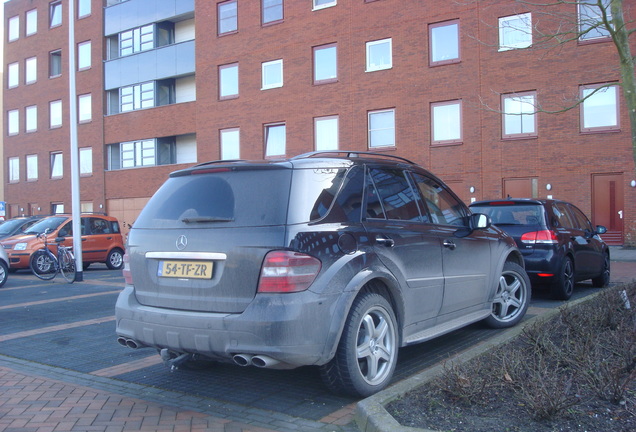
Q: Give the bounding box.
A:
[116,152,531,396]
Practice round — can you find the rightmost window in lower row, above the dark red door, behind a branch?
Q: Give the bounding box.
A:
[581,84,619,132]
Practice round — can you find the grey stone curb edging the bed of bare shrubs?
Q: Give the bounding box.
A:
[354,290,603,432]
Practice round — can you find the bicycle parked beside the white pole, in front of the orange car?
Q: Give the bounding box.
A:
[29,228,77,283]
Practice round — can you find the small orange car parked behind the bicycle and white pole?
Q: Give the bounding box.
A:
[1,214,124,270]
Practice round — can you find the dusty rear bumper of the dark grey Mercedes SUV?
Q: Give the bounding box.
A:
[115,286,343,367]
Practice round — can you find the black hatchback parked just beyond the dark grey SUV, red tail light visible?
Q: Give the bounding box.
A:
[470,199,610,300]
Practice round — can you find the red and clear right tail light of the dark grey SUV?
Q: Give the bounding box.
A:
[258,251,322,293]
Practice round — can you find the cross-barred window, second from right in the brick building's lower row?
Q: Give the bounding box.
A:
[502,92,537,138]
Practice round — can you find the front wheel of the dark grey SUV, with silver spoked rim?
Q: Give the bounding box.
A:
[484,262,532,328]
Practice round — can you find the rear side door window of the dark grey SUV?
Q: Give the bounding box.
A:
[367,168,421,221]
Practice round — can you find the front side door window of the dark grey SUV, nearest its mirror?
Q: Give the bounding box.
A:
[413,174,467,226]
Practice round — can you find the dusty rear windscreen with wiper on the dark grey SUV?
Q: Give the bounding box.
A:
[134,169,291,228]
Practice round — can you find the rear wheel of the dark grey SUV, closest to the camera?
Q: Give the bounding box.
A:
[320,293,399,397]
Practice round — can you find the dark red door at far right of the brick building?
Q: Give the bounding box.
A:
[592,174,624,245]
